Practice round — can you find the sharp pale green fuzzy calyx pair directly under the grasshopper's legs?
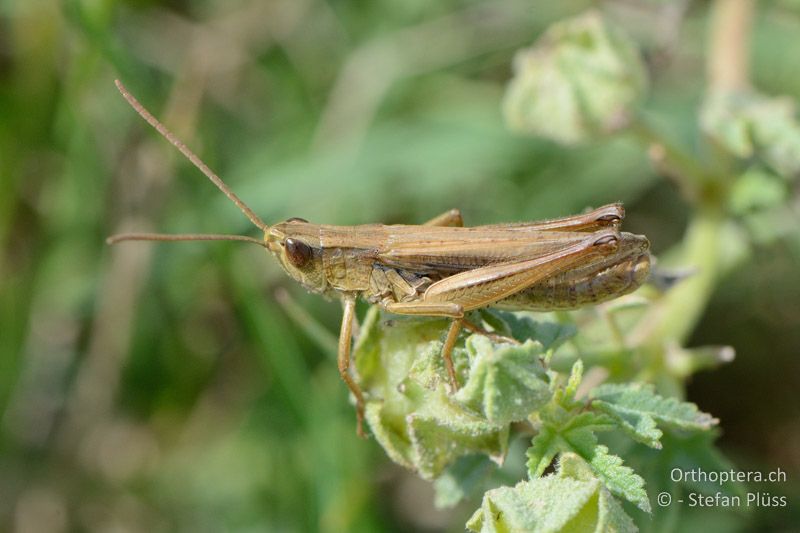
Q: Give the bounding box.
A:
[354,308,550,479]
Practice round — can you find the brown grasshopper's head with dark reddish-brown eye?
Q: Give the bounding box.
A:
[264,218,327,298]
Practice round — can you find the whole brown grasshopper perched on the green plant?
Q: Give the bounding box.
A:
[107,81,650,436]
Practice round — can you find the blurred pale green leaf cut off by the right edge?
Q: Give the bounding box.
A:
[701,88,800,178]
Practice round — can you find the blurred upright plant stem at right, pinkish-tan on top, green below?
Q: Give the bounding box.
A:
[631,0,753,384]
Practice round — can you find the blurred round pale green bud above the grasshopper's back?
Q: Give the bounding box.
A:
[503,11,647,144]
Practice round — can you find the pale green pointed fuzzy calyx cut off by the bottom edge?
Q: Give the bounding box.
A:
[467,454,636,533]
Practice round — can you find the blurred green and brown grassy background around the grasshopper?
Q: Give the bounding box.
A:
[0,0,800,532]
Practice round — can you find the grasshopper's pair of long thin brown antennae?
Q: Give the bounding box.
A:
[106,80,269,247]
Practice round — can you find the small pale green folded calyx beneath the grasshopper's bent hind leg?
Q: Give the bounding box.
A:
[454,335,551,426]
